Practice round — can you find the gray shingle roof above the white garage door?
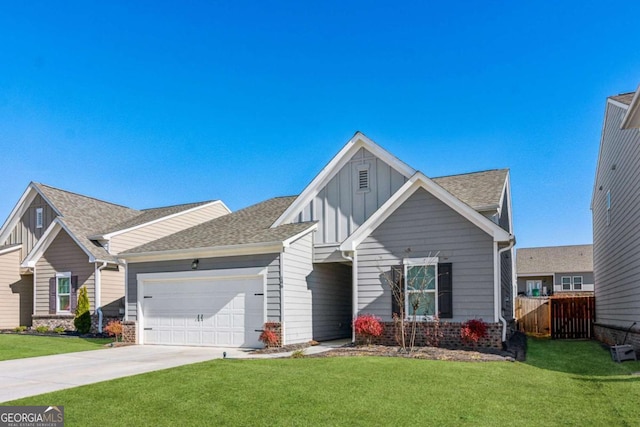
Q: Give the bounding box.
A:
[123,196,313,254]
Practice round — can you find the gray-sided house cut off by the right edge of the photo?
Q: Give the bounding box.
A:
[591,87,640,350]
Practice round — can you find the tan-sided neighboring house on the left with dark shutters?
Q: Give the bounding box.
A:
[0,182,229,329]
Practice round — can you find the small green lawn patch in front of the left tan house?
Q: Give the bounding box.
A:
[0,334,113,360]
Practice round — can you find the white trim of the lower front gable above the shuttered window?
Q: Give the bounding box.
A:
[340,172,512,251]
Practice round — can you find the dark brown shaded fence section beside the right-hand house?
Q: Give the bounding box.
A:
[550,296,596,339]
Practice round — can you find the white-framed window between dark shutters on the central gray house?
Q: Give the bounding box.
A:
[404,258,438,320]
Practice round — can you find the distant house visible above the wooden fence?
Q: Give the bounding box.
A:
[516,245,594,296]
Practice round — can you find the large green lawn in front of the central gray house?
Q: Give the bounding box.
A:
[7,341,640,426]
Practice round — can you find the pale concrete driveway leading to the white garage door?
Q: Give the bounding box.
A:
[0,345,248,404]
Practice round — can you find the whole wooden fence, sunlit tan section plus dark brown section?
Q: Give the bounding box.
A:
[516,295,596,339]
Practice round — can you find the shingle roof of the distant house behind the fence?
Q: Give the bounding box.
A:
[516,245,593,274]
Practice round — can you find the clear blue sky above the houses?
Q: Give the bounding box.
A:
[0,1,640,247]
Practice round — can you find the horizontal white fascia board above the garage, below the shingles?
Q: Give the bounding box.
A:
[118,242,283,264]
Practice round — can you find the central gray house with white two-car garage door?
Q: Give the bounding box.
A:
[121,132,515,347]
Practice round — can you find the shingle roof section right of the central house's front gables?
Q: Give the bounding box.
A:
[432,169,509,211]
